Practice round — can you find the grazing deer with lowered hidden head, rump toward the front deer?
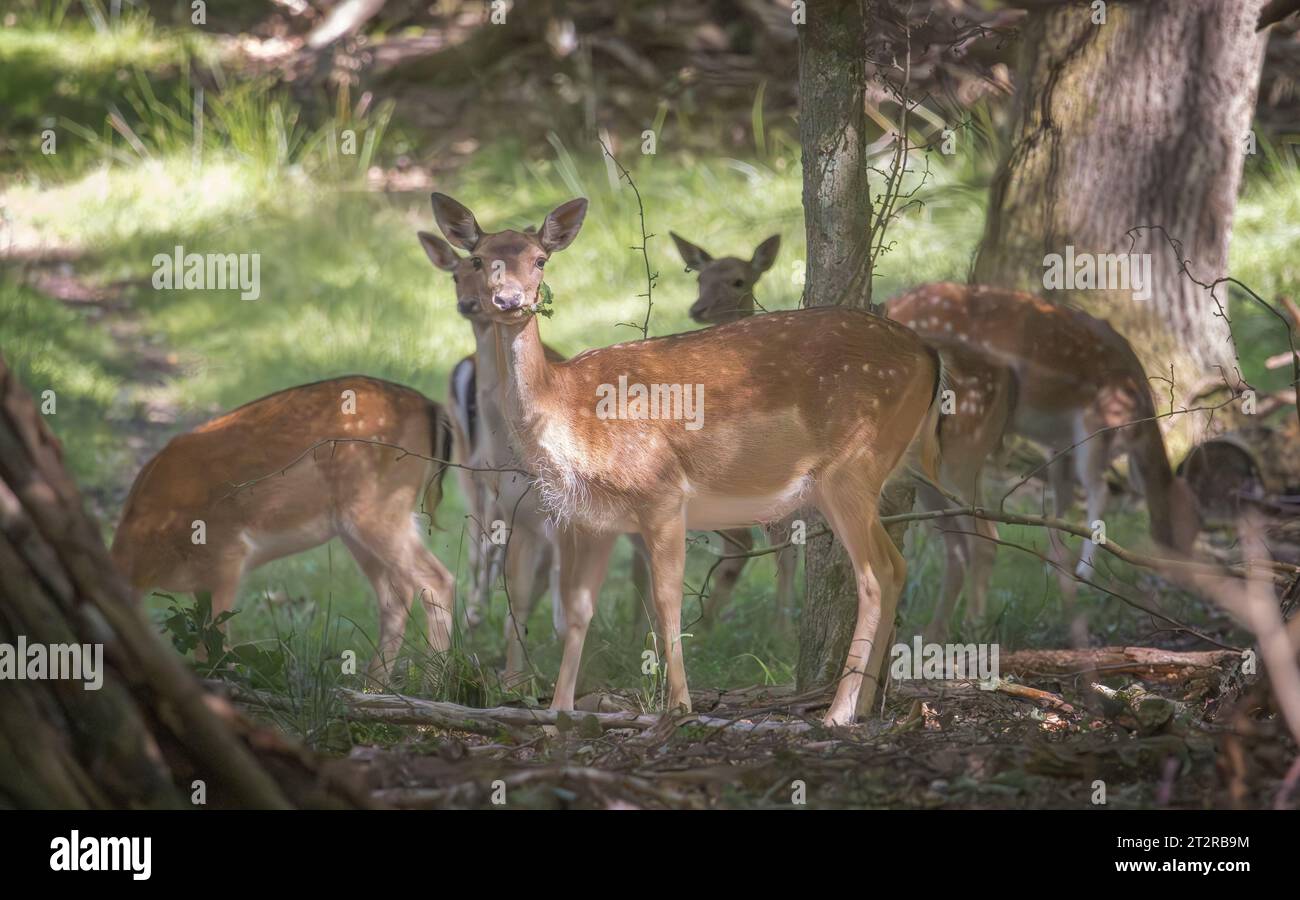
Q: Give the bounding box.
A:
[112,375,455,680]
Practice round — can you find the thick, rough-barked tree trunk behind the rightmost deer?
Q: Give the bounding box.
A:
[972,0,1264,393]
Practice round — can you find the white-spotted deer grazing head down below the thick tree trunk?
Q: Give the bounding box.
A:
[887,282,1200,639]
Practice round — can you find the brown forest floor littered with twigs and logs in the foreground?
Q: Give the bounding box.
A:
[236,652,1300,809]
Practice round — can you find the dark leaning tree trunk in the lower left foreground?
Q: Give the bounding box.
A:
[0,359,365,809]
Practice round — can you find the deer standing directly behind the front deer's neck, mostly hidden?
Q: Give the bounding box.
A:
[419,226,564,684]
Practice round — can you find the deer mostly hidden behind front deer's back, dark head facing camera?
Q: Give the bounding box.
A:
[668,232,798,620]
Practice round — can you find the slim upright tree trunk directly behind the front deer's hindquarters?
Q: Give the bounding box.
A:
[796,0,871,691]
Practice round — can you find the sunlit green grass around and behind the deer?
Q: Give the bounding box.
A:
[0,17,1300,712]
